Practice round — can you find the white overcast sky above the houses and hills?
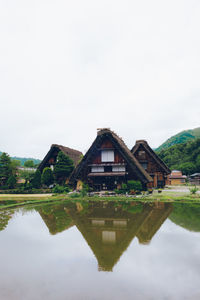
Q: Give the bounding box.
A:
[0,0,200,158]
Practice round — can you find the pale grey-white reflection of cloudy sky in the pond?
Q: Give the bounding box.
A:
[0,206,200,300]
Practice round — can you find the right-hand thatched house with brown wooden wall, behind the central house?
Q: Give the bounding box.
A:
[131,140,171,188]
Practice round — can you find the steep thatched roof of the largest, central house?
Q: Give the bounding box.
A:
[70,128,153,183]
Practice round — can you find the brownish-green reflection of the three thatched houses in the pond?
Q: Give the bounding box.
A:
[37,201,172,271]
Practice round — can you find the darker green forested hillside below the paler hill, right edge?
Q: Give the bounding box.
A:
[157,139,200,175]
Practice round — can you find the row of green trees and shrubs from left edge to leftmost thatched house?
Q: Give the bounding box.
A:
[0,151,74,190]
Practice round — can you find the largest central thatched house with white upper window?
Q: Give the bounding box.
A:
[70,128,153,190]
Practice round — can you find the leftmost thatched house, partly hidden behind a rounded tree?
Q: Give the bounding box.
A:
[38,144,82,173]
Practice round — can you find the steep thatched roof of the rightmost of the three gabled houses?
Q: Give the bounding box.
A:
[131,140,171,174]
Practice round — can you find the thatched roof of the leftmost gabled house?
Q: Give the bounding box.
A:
[38,144,83,171]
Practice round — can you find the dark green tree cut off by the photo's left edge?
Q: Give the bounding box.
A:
[0,152,12,185]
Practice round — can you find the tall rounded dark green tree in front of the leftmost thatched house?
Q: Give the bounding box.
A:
[54,151,74,184]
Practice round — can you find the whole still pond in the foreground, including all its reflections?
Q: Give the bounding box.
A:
[0,201,200,300]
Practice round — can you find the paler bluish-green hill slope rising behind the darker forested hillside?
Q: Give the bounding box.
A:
[156,127,200,151]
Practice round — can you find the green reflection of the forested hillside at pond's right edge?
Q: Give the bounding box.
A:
[170,203,200,232]
